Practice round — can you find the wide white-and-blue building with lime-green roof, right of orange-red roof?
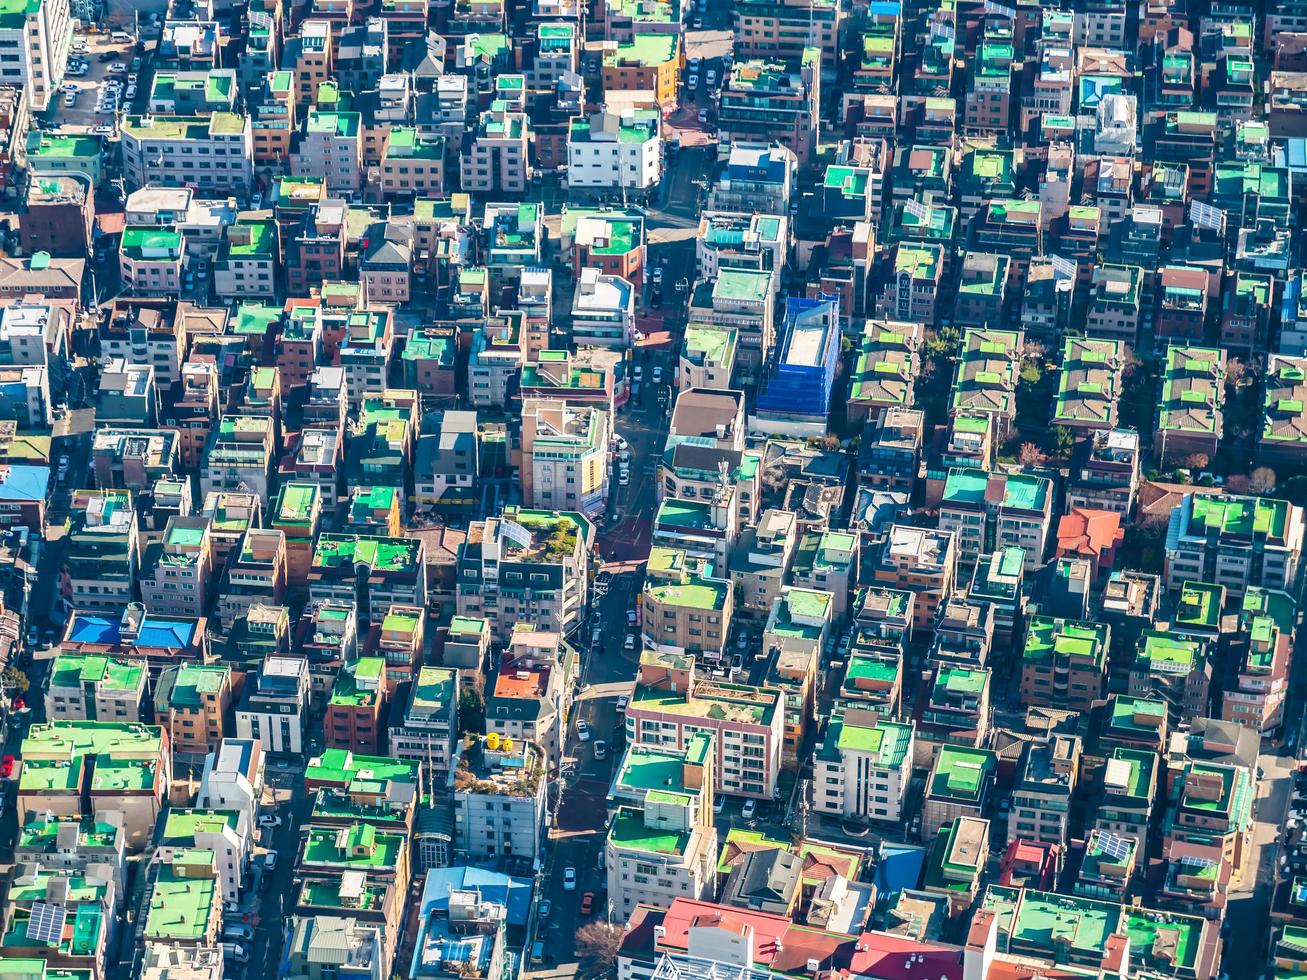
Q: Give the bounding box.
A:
[1163,494,1303,596]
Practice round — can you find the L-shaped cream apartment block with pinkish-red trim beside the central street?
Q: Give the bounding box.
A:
[626,651,784,800]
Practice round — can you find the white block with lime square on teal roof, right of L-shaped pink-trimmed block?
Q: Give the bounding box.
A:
[812,705,914,823]
